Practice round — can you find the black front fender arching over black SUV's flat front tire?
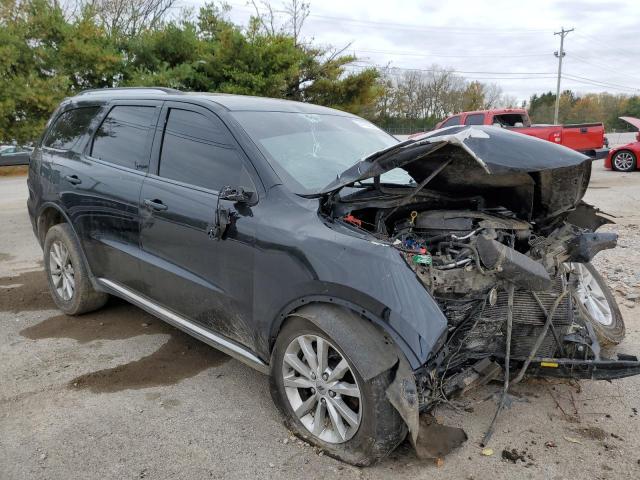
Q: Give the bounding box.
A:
[254,224,447,369]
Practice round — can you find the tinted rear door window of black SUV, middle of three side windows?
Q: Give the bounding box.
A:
[91,105,155,168]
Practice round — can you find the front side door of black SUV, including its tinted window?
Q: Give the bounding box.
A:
[140,102,256,347]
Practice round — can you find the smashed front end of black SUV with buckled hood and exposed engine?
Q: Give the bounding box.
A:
[321,127,640,446]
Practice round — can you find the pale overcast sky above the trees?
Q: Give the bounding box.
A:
[180,0,640,100]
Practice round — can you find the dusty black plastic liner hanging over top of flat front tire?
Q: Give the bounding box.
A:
[289,303,400,381]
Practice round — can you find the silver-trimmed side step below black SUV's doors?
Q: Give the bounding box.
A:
[97,278,269,374]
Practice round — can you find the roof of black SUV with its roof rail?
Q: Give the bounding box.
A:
[67,87,355,117]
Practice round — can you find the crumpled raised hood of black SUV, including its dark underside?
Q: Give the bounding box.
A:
[319,126,591,220]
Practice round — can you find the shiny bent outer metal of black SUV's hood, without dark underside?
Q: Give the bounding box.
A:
[318,125,589,194]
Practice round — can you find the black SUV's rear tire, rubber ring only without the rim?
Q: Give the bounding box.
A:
[43,223,109,315]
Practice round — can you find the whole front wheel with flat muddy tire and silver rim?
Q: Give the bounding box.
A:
[271,318,407,466]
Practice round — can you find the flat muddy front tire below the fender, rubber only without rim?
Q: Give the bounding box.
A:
[271,317,407,466]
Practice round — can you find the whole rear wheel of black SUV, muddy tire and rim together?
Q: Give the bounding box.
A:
[43,223,109,315]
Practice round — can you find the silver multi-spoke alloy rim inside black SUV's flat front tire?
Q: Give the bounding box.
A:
[282,335,362,443]
